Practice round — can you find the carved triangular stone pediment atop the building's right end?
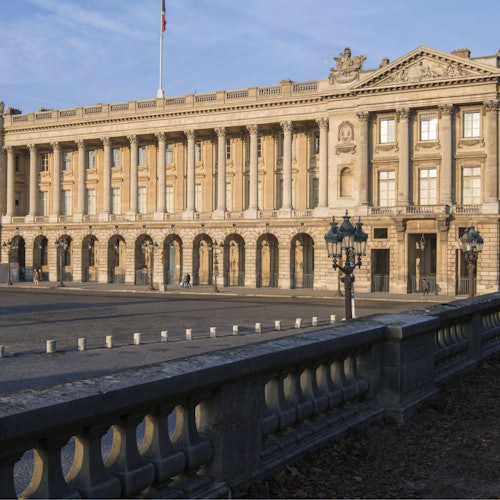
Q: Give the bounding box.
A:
[352,47,500,90]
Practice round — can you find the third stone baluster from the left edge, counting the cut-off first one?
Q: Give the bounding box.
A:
[66,425,121,498]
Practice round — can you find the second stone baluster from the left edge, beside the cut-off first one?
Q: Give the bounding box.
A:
[19,436,80,498]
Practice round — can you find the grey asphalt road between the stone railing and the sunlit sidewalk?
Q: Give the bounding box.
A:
[0,287,430,394]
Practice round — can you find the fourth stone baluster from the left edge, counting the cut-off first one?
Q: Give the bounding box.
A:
[105,415,155,497]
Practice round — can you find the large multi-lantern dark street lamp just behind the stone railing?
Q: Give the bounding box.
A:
[325,210,368,320]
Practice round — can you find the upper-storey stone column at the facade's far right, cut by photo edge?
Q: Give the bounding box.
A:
[483,101,499,207]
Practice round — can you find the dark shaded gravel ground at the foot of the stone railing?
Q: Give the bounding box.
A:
[233,353,500,499]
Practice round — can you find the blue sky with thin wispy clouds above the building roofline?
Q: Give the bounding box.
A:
[0,0,500,113]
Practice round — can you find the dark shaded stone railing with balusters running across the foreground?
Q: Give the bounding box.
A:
[0,294,500,498]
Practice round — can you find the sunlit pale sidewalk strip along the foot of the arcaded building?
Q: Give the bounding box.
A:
[0,281,458,304]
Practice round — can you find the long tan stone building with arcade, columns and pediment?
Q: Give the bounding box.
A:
[0,47,500,295]
